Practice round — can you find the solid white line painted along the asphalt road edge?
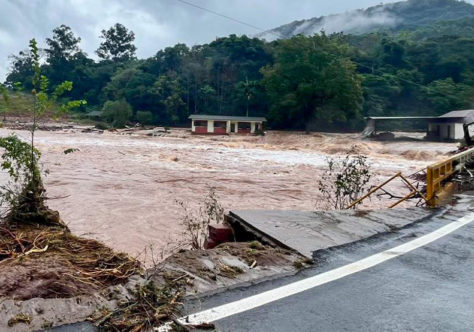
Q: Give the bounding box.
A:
[158,213,474,331]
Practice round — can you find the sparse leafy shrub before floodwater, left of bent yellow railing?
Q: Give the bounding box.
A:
[318,147,372,210]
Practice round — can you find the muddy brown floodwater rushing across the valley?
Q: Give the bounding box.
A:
[0,128,456,260]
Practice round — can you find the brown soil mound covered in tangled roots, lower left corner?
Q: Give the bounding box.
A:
[0,225,140,300]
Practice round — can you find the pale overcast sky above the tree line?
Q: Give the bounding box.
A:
[0,0,474,81]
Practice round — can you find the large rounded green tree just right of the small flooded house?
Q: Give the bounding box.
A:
[262,34,362,128]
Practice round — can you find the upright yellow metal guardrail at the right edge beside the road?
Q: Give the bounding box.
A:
[426,148,474,206]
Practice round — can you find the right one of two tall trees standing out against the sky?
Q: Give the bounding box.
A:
[96,23,137,61]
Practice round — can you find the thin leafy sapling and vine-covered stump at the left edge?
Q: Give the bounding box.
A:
[0,39,85,223]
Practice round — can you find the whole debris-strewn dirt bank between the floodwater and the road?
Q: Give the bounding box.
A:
[0,219,302,331]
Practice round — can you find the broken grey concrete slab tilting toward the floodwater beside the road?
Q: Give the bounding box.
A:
[227,208,434,258]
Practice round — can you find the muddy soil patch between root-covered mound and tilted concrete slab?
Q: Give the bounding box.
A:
[149,241,302,295]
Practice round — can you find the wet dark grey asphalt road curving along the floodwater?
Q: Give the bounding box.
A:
[186,198,474,332]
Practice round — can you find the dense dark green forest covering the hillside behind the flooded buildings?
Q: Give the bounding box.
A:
[0,12,474,130]
